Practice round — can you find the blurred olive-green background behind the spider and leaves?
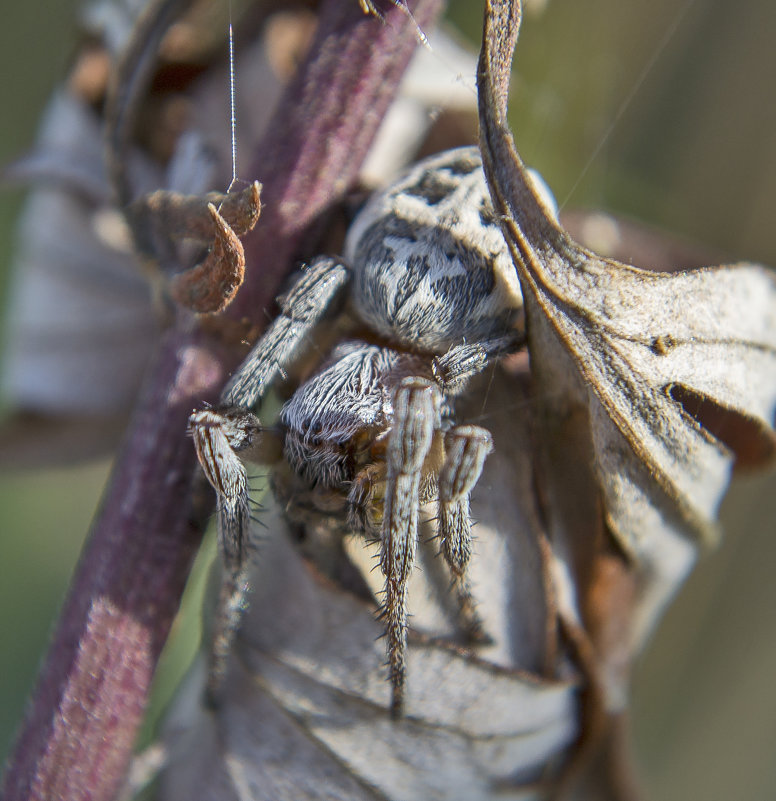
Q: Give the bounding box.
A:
[0,0,776,801]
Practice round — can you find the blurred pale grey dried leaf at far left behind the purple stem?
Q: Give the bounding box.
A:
[3,93,160,415]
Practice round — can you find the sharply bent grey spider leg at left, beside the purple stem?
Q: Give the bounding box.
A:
[189,257,350,698]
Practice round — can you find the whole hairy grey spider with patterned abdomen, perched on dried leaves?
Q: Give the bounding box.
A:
[190,147,524,717]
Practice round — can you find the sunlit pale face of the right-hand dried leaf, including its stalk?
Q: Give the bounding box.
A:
[480,0,776,556]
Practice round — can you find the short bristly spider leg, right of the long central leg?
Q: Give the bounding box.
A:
[438,425,493,640]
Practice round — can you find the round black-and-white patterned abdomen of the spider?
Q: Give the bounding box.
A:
[344,147,522,353]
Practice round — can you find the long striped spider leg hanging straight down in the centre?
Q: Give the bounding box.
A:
[380,378,441,717]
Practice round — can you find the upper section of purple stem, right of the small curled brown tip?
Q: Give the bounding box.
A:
[230,0,444,320]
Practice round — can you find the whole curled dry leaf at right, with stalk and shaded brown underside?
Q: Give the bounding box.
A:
[478,0,776,788]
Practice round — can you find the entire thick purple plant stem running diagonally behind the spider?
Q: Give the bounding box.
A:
[2,0,442,801]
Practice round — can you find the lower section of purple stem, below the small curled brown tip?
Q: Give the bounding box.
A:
[3,330,223,800]
